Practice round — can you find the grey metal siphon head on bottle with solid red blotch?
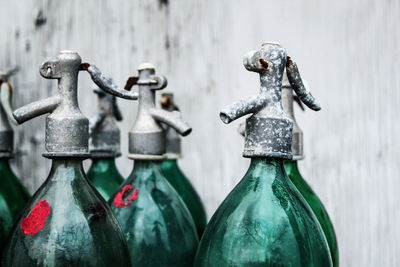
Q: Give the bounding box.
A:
[1,50,126,157]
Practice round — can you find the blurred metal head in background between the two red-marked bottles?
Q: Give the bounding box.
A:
[89,86,122,158]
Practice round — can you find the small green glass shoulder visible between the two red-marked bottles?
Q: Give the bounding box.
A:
[86,158,124,201]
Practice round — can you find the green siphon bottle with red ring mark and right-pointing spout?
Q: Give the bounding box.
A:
[88,63,198,266]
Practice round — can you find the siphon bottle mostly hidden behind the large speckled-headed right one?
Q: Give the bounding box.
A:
[282,73,339,267]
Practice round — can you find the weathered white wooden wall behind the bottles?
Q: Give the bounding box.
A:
[0,0,400,266]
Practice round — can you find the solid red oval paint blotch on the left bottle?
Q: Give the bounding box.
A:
[21,200,50,235]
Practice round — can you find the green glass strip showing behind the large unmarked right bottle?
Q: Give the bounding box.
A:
[284,160,339,267]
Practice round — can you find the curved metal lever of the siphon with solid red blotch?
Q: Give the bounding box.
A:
[85,63,139,100]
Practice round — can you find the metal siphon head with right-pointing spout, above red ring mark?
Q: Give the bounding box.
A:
[96,63,192,160]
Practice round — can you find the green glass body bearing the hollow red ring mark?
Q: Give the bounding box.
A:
[109,160,199,266]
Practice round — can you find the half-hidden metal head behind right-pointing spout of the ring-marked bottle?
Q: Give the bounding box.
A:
[160,93,181,159]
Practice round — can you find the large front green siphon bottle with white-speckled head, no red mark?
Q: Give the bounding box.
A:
[195,43,332,267]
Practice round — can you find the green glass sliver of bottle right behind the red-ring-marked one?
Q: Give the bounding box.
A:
[161,159,207,237]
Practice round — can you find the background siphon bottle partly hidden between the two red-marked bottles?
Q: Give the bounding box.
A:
[87,88,124,201]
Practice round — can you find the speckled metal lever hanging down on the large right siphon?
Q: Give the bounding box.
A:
[286,57,321,111]
